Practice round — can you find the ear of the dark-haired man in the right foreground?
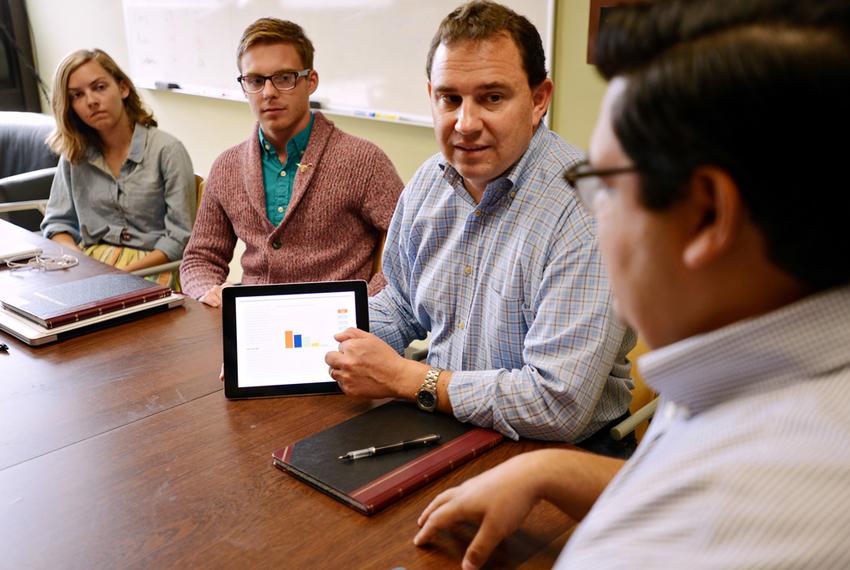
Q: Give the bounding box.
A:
[682,166,747,269]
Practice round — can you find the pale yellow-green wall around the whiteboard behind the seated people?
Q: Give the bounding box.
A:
[26,0,604,180]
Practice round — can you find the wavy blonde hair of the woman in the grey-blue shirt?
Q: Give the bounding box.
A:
[47,48,156,164]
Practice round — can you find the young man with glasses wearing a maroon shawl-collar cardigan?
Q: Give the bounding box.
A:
[180,18,403,307]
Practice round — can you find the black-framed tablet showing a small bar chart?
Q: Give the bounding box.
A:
[222,281,369,399]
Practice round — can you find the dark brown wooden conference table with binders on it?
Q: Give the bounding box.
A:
[0,221,573,569]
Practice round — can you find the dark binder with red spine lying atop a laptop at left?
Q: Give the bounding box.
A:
[0,273,171,329]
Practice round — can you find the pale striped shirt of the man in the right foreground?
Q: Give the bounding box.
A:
[557,287,850,569]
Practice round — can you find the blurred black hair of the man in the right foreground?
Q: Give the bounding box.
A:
[595,0,850,290]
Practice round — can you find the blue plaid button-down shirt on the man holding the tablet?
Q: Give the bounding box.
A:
[369,125,634,441]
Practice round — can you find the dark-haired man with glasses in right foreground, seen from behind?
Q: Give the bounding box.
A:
[414,0,850,570]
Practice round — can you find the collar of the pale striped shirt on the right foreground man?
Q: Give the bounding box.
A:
[638,286,850,414]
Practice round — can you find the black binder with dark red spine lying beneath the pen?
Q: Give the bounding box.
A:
[273,401,502,515]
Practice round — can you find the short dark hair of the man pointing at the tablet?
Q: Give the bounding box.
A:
[425,0,546,88]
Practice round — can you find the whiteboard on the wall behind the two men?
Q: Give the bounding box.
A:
[124,0,555,126]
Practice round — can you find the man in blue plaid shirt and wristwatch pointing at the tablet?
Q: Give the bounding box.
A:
[326,2,634,450]
